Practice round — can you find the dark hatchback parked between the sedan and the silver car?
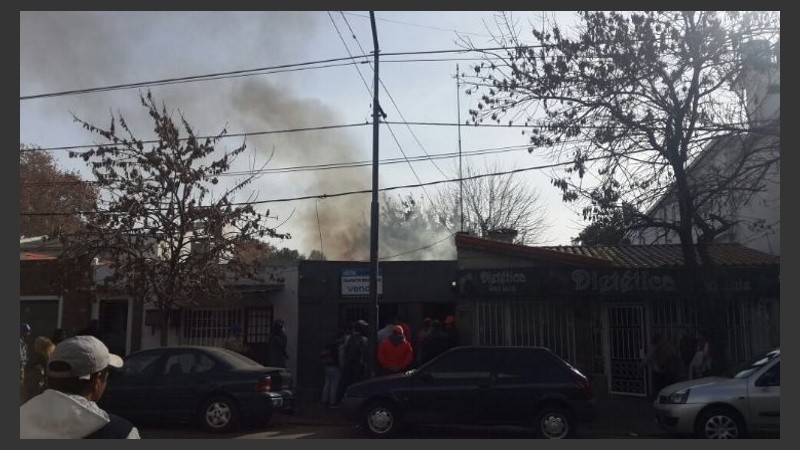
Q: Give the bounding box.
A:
[342,347,594,438]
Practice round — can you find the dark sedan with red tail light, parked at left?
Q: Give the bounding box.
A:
[100,346,293,432]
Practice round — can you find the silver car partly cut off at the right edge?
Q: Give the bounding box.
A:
[653,349,781,439]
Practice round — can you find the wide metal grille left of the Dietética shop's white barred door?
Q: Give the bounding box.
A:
[473,300,575,364]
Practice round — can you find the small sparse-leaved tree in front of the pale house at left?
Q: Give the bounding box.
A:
[65,92,289,345]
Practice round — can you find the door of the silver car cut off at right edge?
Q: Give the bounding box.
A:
[747,358,781,432]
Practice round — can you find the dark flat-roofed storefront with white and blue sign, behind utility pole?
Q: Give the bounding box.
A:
[296,261,456,390]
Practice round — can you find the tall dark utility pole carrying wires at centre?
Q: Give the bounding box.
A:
[369,11,381,372]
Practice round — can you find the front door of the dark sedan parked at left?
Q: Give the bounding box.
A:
[99,350,163,421]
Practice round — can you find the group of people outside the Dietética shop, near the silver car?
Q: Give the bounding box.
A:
[641,329,711,394]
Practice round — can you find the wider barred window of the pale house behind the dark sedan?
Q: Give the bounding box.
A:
[180,309,243,347]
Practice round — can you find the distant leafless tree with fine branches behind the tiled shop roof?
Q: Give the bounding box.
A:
[432,163,549,245]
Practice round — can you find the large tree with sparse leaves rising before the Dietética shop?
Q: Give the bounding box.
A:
[467,11,780,370]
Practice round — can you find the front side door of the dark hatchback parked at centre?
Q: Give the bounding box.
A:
[395,348,492,424]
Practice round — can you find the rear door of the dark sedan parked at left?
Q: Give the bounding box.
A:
[153,349,216,420]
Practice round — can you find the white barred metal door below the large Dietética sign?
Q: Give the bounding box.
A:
[608,305,647,396]
